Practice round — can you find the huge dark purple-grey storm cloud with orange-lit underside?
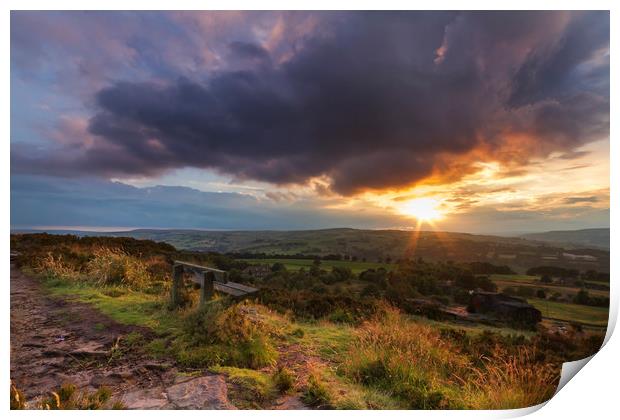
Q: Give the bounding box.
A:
[12,12,609,194]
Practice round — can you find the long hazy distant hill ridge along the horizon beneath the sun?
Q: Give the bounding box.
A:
[10,228,609,272]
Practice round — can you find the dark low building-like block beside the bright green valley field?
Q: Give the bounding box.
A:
[467,292,542,325]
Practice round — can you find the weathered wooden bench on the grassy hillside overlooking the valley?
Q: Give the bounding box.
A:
[170,261,258,308]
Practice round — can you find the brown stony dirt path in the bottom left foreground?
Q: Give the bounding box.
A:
[11,264,235,409]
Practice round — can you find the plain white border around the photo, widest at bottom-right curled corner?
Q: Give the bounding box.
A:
[0,0,620,420]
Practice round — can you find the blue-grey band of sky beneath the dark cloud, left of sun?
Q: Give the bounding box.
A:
[11,175,408,230]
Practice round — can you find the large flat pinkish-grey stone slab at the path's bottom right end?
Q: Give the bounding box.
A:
[166,375,236,410]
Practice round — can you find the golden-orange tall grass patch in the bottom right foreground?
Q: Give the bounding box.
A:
[340,309,559,409]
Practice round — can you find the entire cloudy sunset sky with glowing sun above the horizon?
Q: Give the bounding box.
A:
[10,11,610,233]
